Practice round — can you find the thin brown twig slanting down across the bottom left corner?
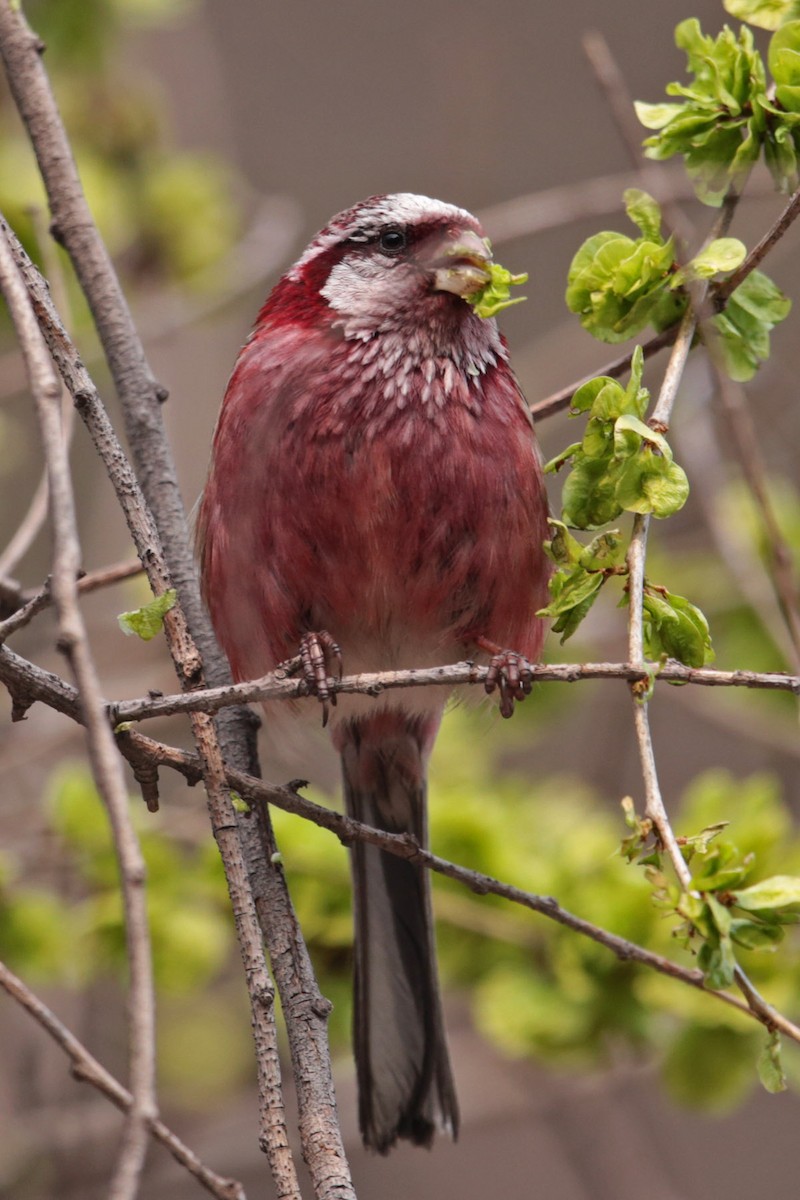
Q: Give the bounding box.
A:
[0,962,246,1200]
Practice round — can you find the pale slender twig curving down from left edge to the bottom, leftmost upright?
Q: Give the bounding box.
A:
[0,220,157,1200]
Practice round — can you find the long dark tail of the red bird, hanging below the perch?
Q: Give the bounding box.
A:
[336,710,458,1154]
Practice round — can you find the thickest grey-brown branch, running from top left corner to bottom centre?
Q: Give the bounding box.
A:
[0,0,354,1200]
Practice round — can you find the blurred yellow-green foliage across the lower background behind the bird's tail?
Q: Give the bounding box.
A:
[9,739,800,1108]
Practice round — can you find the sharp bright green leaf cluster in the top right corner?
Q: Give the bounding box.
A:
[636,17,800,205]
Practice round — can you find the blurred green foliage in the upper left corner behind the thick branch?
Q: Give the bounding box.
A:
[0,0,240,292]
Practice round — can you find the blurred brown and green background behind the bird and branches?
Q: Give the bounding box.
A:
[0,0,800,1200]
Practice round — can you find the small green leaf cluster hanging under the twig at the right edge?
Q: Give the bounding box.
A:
[711,271,792,383]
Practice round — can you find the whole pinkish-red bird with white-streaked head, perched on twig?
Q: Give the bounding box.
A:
[198,193,548,1152]
